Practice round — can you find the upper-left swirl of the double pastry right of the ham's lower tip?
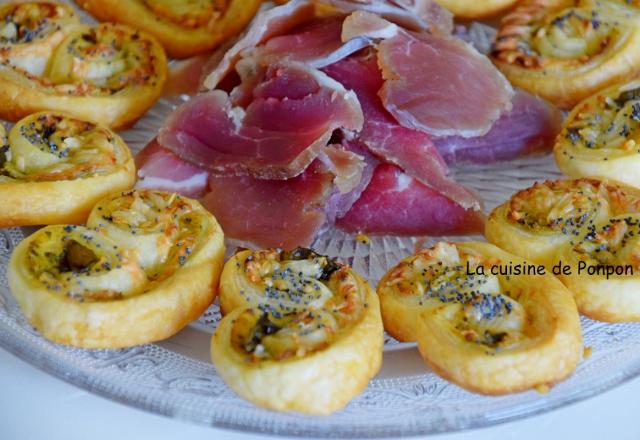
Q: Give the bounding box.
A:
[485,179,640,266]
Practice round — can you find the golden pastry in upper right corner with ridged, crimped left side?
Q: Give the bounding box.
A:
[492,0,640,110]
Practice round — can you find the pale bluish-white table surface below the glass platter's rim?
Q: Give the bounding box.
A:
[0,349,640,440]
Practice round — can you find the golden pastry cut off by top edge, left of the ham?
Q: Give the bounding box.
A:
[76,0,260,58]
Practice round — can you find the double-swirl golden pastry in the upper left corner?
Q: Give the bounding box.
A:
[0,2,167,129]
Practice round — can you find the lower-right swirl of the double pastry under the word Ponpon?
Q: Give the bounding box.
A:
[558,214,640,322]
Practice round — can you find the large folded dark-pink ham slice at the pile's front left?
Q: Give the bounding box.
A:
[158,63,363,179]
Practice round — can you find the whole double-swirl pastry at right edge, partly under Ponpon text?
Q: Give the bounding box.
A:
[485,179,640,322]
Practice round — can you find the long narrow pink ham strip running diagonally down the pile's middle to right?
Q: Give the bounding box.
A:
[324,54,480,209]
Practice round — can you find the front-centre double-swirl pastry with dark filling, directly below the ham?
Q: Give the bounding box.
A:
[211,248,384,414]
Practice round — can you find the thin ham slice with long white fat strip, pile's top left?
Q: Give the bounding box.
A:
[203,0,315,90]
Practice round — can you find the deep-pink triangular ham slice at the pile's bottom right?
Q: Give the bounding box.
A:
[336,164,484,235]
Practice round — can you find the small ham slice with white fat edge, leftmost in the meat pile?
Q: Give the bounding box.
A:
[135,139,209,198]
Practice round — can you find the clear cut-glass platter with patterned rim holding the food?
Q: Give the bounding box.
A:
[0,5,640,438]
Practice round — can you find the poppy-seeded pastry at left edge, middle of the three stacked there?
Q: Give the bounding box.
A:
[0,112,135,227]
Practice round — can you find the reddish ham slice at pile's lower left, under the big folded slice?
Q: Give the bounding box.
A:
[203,161,333,248]
